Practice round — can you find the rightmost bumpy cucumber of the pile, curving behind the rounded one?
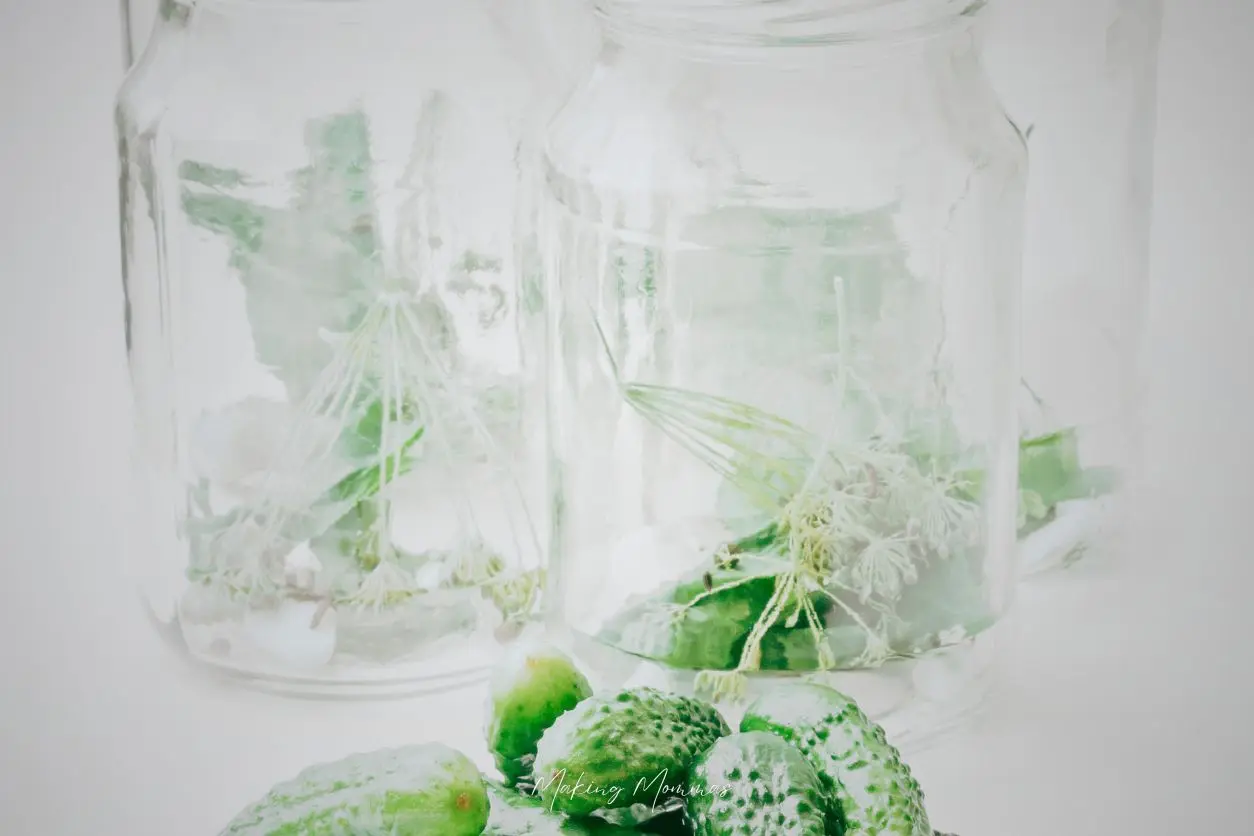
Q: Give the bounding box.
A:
[740,683,933,836]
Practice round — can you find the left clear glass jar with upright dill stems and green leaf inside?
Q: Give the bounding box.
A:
[117,0,544,696]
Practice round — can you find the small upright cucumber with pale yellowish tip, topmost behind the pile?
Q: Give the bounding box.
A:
[487,642,592,786]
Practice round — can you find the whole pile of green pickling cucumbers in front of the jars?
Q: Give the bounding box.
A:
[221,642,958,836]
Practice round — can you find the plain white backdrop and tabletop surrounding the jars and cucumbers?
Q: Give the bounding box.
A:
[0,0,1254,836]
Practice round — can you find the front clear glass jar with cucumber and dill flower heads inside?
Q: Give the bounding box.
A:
[544,0,1026,743]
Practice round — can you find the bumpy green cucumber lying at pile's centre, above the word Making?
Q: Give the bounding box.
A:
[535,688,731,816]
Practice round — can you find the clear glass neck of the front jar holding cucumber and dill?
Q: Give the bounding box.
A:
[594,0,988,60]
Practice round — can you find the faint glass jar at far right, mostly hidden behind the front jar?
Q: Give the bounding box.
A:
[983,0,1162,572]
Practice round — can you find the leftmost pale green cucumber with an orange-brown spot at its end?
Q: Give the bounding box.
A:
[219,743,489,836]
